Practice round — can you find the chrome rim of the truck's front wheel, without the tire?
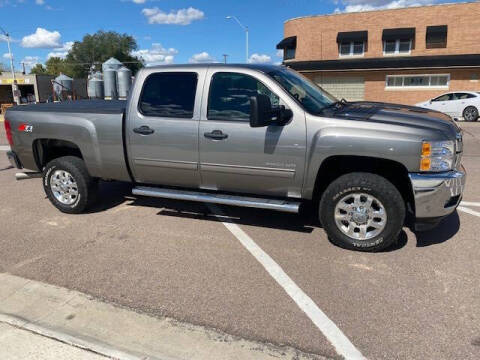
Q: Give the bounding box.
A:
[334,193,387,241]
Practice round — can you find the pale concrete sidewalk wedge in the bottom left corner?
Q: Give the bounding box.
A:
[0,323,106,360]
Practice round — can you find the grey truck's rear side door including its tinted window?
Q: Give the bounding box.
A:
[127,68,206,187]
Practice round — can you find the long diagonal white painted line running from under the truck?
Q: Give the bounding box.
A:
[207,204,365,360]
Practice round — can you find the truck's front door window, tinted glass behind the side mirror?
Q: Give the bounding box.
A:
[208,73,280,121]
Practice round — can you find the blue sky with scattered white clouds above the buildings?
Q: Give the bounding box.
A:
[0,0,470,71]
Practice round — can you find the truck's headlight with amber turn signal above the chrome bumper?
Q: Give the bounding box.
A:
[420,141,455,171]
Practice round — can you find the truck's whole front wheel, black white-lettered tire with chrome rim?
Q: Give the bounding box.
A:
[319,172,406,252]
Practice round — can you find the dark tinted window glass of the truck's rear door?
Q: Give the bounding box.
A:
[139,72,198,119]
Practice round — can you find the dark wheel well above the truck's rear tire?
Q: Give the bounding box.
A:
[33,139,83,170]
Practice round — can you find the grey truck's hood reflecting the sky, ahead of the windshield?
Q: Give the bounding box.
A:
[331,101,460,139]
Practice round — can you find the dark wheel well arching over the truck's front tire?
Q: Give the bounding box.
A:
[313,156,415,211]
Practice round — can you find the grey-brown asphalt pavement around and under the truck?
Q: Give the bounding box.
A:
[0,123,480,359]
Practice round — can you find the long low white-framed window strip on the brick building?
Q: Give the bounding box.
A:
[385,74,450,89]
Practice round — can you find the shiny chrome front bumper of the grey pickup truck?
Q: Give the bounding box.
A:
[408,166,466,219]
